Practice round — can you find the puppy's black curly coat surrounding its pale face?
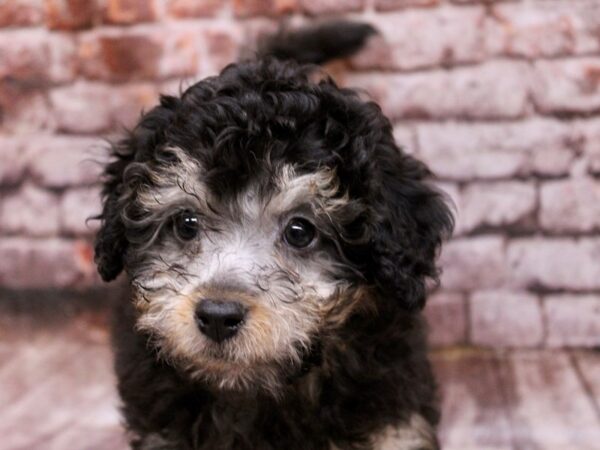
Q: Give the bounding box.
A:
[96,21,452,450]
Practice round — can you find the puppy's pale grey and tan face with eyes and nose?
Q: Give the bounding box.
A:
[128,154,368,389]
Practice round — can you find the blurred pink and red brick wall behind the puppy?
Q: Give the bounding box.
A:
[0,0,600,347]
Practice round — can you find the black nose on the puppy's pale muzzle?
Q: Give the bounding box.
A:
[196,299,246,342]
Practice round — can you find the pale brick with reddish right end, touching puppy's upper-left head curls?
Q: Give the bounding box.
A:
[50,82,158,133]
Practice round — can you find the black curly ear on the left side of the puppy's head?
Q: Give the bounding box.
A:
[94,96,179,281]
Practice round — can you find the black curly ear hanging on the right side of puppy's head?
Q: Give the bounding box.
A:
[371,140,454,310]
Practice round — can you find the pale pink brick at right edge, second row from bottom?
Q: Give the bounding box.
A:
[507,237,600,290]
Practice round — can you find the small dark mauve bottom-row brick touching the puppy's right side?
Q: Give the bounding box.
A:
[425,292,467,346]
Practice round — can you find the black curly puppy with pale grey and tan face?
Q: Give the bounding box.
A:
[95,22,452,450]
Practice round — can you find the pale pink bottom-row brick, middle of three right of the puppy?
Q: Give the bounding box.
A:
[470,291,544,347]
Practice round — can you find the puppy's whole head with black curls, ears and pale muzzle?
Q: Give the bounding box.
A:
[96,59,452,390]
